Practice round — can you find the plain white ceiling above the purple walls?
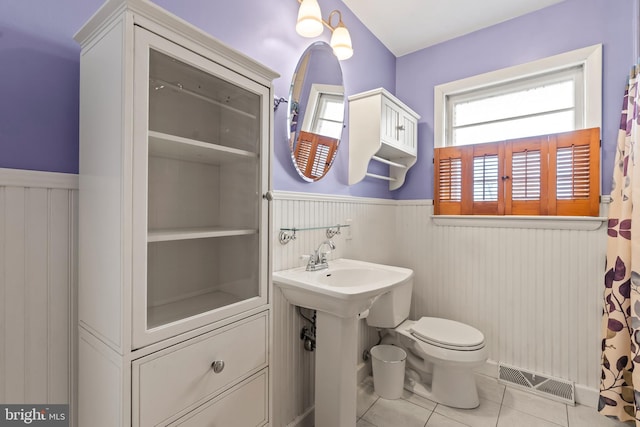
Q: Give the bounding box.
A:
[342,0,564,57]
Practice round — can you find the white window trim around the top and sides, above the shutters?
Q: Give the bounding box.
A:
[434,44,602,148]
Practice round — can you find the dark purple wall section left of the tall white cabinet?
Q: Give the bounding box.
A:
[0,0,100,173]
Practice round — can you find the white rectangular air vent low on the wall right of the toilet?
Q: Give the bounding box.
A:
[498,363,576,405]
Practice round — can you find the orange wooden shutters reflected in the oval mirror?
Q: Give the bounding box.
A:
[294,131,338,178]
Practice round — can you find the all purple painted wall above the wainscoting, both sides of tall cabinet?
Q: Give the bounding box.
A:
[0,0,636,199]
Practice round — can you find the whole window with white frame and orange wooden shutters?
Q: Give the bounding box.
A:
[434,45,602,216]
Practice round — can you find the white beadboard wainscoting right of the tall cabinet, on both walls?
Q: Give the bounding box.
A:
[273,192,606,427]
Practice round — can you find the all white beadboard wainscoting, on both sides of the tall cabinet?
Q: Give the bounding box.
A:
[0,176,606,427]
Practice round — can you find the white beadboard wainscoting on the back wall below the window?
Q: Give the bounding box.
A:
[393,202,607,406]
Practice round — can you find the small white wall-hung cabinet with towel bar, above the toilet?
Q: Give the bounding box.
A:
[349,88,420,190]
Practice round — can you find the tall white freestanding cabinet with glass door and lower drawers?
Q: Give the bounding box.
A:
[76,0,277,427]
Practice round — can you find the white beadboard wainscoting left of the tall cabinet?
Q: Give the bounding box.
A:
[0,169,78,414]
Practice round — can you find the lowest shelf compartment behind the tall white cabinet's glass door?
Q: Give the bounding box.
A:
[147,234,259,329]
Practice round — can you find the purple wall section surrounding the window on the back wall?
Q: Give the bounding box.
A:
[396,0,637,199]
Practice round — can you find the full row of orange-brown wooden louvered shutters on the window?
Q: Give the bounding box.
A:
[434,128,600,216]
